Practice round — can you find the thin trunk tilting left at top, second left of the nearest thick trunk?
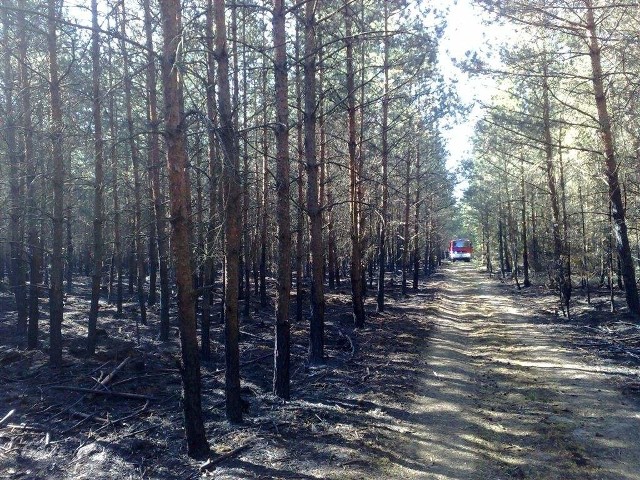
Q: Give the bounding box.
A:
[120,2,147,325]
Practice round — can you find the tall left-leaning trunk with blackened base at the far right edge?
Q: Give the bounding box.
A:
[584,0,640,315]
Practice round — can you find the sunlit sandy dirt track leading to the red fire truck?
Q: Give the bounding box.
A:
[385,264,640,480]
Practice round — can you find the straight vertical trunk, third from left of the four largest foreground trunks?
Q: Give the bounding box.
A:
[273,0,291,399]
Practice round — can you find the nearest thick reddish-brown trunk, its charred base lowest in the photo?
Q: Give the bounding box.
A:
[159,0,209,457]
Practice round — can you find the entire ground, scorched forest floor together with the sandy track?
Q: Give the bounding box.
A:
[0,264,640,480]
